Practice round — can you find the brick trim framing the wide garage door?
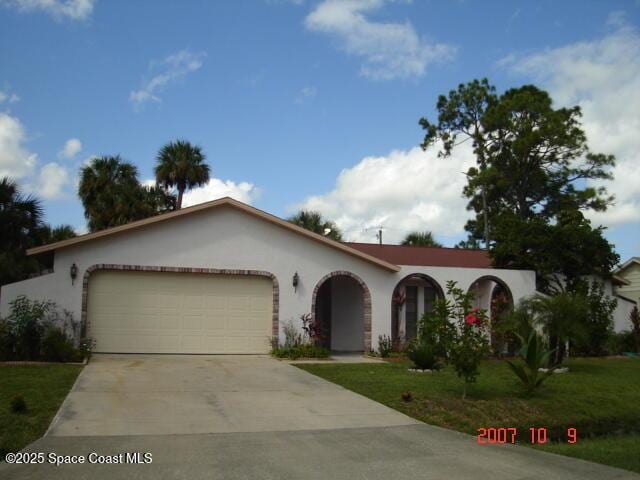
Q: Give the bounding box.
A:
[80,263,280,340]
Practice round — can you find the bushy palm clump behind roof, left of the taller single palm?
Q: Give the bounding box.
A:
[78,156,171,232]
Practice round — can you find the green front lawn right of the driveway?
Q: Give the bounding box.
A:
[298,358,640,471]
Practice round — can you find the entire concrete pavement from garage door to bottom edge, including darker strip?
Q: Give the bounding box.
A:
[0,355,640,480]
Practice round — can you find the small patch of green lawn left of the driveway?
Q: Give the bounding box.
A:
[0,364,82,459]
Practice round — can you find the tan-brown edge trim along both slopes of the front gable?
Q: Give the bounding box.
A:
[27,197,400,272]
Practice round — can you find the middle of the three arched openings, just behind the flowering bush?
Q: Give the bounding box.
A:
[391,273,444,345]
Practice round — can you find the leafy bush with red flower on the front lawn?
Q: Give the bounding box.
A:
[419,281,489,398]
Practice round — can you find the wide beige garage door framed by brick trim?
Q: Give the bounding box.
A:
[87,271,273,353]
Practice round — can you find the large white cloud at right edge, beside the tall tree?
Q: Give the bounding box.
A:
[502,20,640,226]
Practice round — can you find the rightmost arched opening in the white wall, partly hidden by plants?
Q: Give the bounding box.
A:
[469,275,516,355]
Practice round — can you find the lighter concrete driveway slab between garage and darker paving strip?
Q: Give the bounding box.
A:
[48,355,418,436]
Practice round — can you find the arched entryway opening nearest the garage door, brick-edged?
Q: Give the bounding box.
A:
[311,271,371,352]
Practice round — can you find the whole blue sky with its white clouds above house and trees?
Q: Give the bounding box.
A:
[0,0,640,260]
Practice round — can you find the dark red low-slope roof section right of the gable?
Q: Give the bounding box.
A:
[344,242,491,268]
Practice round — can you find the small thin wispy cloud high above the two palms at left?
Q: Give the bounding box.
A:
[129,50,206,109]
